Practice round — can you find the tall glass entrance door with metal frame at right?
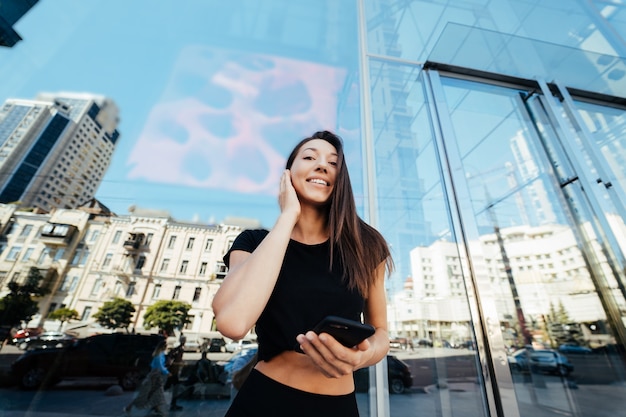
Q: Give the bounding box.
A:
[427,72,626,417]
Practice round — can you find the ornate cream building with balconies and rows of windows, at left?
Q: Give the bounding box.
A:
[0,200,247,332]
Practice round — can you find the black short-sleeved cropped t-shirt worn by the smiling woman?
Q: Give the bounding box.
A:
[224,229,364,360]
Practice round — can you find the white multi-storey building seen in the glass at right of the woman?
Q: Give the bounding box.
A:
[389,225,626,342]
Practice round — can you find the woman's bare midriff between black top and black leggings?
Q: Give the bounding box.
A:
[255,351,354,395]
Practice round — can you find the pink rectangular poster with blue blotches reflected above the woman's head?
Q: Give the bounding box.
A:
[128,46,345,193]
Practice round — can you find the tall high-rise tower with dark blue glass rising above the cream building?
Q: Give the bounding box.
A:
[0,93,119,211]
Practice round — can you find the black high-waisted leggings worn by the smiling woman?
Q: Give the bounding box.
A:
[225,369,359,417]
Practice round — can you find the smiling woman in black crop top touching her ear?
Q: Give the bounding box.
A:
[213,131,392,417]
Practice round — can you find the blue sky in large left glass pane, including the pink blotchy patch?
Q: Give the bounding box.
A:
[0,0,358,227]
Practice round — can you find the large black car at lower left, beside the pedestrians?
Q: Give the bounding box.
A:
[11,333,163,390]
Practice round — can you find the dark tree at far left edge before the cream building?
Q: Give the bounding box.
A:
[0,267,50,327]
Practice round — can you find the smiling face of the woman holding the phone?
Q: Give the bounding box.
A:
[291,139,339,205]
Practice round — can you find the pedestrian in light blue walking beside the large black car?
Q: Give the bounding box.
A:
[124,340,169,416]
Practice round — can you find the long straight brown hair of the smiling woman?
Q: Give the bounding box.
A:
[286,130,393,297]
